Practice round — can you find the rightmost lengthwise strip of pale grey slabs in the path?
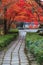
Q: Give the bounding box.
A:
[19,41,29,65]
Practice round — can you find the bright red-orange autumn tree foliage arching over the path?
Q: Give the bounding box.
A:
[0,0,43,23]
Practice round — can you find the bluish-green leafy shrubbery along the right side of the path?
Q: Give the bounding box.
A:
[25,33,43,65]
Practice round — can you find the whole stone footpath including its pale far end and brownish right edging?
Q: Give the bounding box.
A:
[0,31,38,65]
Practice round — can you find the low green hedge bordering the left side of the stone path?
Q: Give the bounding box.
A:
[0,34,18,50]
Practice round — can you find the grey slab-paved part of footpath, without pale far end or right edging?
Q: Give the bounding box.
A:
[0,37,29,65]
